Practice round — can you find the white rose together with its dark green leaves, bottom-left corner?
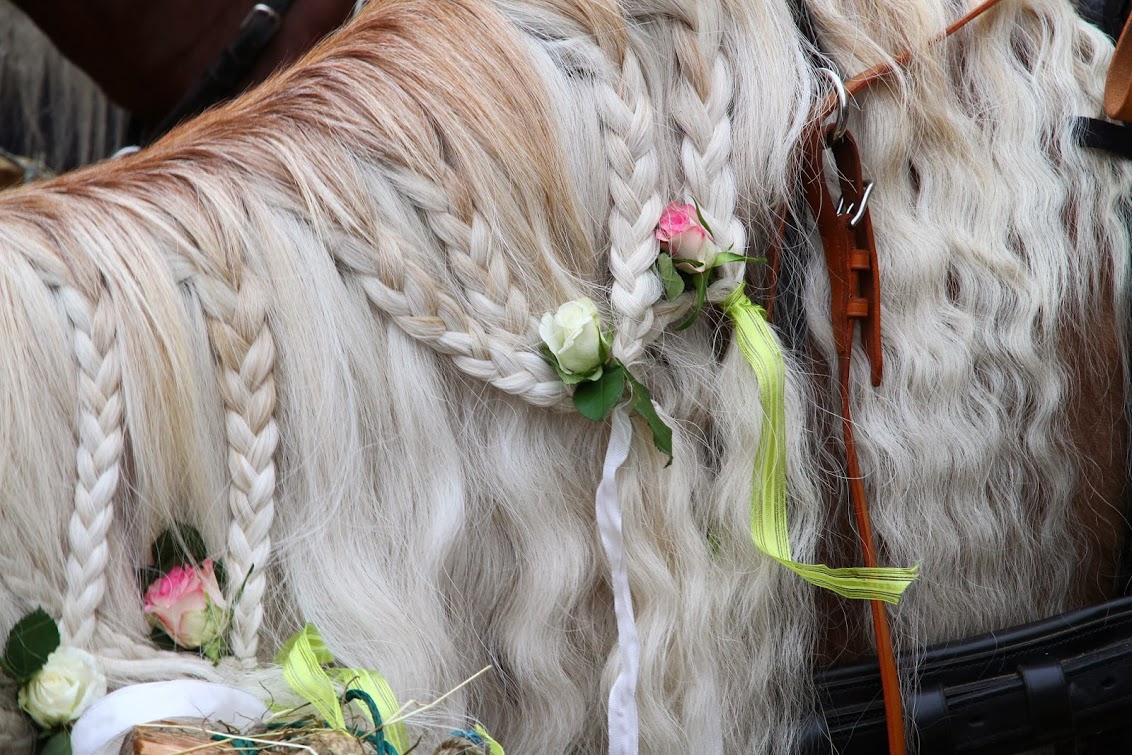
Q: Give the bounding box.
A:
[0,608,106,755]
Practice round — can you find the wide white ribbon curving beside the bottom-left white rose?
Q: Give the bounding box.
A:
[71,679,267,755]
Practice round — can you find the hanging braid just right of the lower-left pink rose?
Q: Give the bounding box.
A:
[195,268,278,661]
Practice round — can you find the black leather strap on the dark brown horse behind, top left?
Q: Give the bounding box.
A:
[142,0,293,144]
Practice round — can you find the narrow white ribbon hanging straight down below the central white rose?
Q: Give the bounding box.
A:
[595,405,641,755]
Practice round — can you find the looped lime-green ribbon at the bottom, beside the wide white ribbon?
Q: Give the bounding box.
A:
[275,624,409,753]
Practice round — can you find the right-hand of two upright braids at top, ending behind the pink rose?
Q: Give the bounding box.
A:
[672,0,746,281]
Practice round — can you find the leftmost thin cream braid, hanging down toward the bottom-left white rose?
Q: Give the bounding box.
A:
[55,286,125,647]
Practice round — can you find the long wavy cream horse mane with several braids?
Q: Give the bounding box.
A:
[0,0,1132,753]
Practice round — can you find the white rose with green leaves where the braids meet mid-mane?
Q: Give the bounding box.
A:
[539,298,672,463]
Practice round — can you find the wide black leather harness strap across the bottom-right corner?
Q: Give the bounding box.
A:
[798,598,1132,755]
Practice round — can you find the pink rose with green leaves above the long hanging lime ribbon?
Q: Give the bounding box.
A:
[657,200,766,331]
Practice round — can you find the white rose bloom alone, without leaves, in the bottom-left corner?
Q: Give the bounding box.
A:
[19,645,106,729]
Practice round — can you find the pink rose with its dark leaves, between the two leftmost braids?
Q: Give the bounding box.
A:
[142,524,238,663]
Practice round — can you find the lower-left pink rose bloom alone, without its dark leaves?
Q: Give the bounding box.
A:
[145,559,228,647]
